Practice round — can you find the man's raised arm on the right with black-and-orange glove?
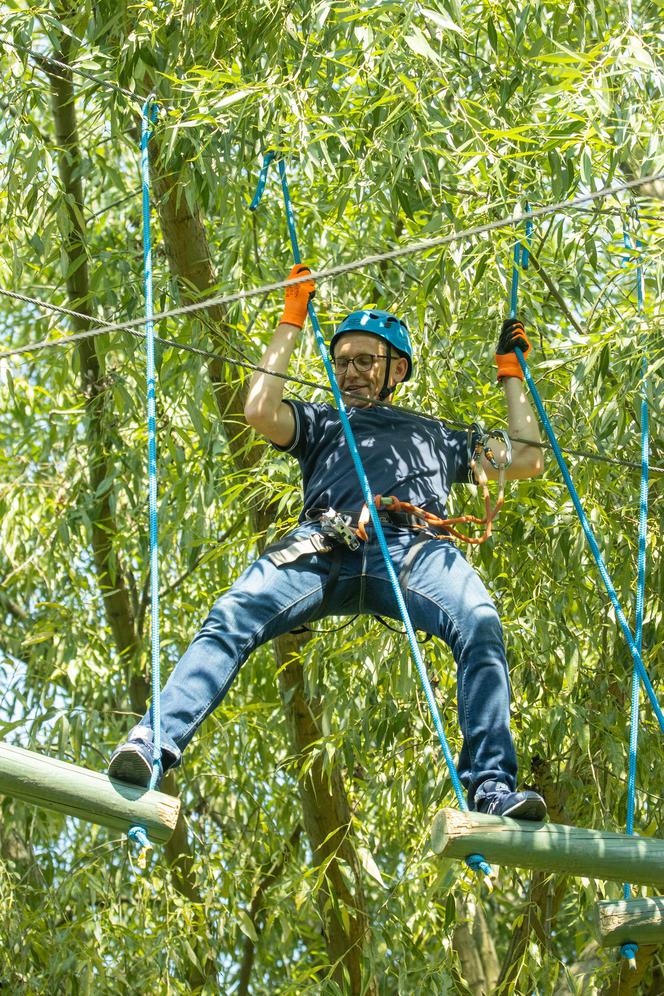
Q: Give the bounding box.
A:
[482,318,544,481]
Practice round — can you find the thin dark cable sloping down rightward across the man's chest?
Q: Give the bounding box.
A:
[0,287,664,474]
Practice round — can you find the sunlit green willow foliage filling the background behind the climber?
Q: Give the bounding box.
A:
[0,0,664,994]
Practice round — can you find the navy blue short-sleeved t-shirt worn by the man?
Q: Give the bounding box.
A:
[276,399,468,520]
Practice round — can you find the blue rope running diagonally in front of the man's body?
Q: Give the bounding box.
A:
[252,152,491,875]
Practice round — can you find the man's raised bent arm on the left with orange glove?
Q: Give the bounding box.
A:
[244,265,314,447]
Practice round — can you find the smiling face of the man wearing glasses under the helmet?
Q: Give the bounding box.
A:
[334,332,408,408]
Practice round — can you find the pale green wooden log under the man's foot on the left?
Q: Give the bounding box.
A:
[0,743,180,843]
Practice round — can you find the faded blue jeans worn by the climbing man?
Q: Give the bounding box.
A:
[131,523,516,806]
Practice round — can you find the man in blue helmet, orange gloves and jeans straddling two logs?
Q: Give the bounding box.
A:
[109,266,546,819]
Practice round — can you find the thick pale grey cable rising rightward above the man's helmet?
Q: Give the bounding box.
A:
[0,172,664,359]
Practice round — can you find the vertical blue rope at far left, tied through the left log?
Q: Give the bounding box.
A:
[129,95,161,848]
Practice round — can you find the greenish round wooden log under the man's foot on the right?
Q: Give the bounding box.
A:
[431,809,664,888]
